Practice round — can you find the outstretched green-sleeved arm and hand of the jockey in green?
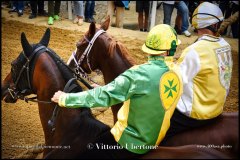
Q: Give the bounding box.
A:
[59,74,135,108]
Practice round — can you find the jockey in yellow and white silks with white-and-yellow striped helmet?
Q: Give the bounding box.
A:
[163,2,233,141]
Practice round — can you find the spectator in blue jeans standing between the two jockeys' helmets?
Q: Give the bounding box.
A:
[163,1,191,37]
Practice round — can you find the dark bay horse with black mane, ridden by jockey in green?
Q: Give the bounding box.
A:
[1,29,232,159]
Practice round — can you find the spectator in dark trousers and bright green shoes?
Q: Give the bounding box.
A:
[48,1,61,25]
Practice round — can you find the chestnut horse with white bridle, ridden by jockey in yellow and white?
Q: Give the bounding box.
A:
[69,18,238,156]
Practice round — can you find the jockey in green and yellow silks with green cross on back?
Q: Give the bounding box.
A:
[52,24,182,158]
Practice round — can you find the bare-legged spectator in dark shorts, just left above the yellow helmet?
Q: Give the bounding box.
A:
[136,1,150,32]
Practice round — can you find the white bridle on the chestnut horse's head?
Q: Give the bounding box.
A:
[70,29,106,84]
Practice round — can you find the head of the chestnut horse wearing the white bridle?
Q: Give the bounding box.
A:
[67,16,110,74]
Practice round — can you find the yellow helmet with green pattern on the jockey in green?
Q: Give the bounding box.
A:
[142,24,181,56]
